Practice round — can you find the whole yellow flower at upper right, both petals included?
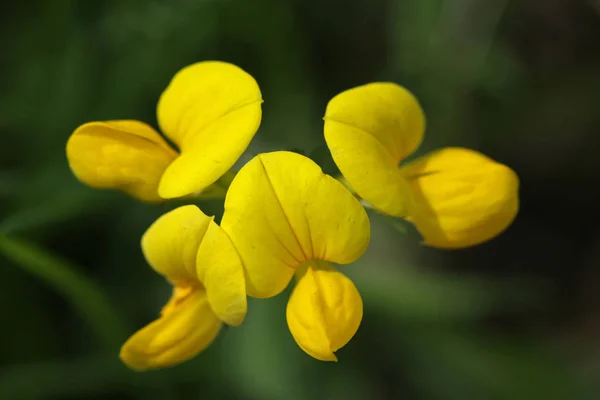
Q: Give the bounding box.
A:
[324,83,519,248]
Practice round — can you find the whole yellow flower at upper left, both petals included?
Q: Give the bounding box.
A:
[67,61,262,202]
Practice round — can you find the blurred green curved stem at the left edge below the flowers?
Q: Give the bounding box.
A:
[0,233,126,352]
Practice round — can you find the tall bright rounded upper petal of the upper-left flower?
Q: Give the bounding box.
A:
[157,61,262,198]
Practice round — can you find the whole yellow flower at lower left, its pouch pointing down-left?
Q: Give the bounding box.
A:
[120,205,247,370]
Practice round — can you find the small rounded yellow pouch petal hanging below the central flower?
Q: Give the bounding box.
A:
[287,262,363,361]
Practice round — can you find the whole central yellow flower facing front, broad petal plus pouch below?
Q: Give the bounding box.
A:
[221,151,370,361]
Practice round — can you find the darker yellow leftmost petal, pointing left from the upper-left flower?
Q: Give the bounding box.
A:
[67,121,177,202]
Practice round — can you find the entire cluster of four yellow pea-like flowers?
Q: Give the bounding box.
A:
[67,62,518,370]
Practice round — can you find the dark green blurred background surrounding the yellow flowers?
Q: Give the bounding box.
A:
[0,0,600,400]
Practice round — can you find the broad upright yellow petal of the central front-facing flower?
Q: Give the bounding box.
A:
[221,151,370,297]
